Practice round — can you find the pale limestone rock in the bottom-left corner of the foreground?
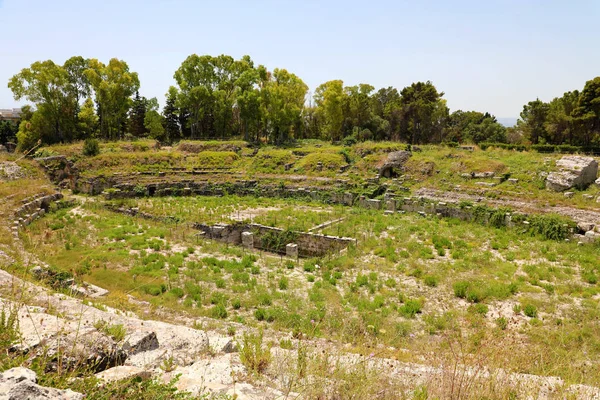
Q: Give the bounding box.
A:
[0,367,83,400]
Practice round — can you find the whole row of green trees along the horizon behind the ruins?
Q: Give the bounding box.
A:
[8,54,600,149]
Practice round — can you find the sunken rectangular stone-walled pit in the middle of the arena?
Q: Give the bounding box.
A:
[193,223,356,257]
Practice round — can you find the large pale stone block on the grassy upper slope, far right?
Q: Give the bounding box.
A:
[546,156,598,192]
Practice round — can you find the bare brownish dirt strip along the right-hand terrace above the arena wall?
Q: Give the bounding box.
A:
[415,188,600,226]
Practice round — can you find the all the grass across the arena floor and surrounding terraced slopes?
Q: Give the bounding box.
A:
[0,142,600,398]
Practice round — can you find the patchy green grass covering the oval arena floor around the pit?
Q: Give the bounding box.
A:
[16,196,600,388]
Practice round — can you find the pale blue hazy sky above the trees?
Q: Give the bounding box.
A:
[0,0,600,117]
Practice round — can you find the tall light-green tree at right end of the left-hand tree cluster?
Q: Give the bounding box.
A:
[85,58,140,139]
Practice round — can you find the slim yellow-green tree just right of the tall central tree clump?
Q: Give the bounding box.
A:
[314,80,345,142]
